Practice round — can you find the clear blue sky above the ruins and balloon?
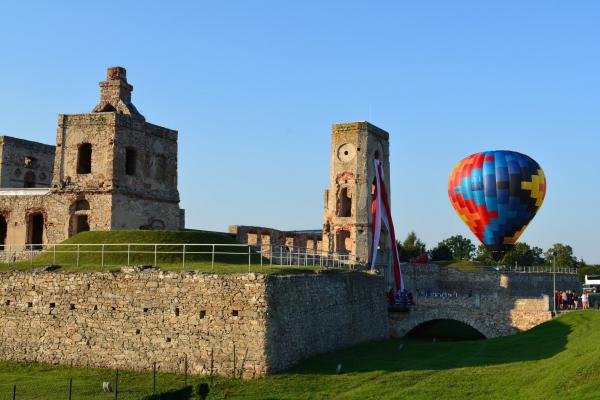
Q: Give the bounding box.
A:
[0,1,600,263]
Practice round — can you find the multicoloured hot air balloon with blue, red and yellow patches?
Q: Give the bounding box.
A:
[448,150,546,261]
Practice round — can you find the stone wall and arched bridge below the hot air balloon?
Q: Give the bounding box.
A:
[387,264,581,338]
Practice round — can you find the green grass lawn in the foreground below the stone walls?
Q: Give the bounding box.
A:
[0,311,600,400]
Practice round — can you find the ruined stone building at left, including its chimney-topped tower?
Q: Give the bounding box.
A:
[0,67,184,246]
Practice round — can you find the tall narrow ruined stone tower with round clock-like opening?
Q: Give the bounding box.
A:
[323,122,391,263]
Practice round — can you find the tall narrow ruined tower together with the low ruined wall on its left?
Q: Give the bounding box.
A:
[229,122,391,264]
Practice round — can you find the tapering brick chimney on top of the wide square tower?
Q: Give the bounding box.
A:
[93,67,141,116]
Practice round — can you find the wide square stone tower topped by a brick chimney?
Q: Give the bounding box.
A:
[52,67,184,235]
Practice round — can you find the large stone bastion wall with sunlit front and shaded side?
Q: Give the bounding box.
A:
[0,269,389,377]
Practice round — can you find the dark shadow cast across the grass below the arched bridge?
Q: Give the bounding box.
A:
[287,318,573,375]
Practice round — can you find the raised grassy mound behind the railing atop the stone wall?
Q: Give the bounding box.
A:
[0,230,318,274]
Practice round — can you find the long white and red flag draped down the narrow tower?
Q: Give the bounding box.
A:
[371,159,404,290]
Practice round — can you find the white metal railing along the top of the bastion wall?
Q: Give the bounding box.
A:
[0,243,357,272]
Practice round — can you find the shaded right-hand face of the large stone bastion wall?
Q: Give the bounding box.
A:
[267,273,389,372]
